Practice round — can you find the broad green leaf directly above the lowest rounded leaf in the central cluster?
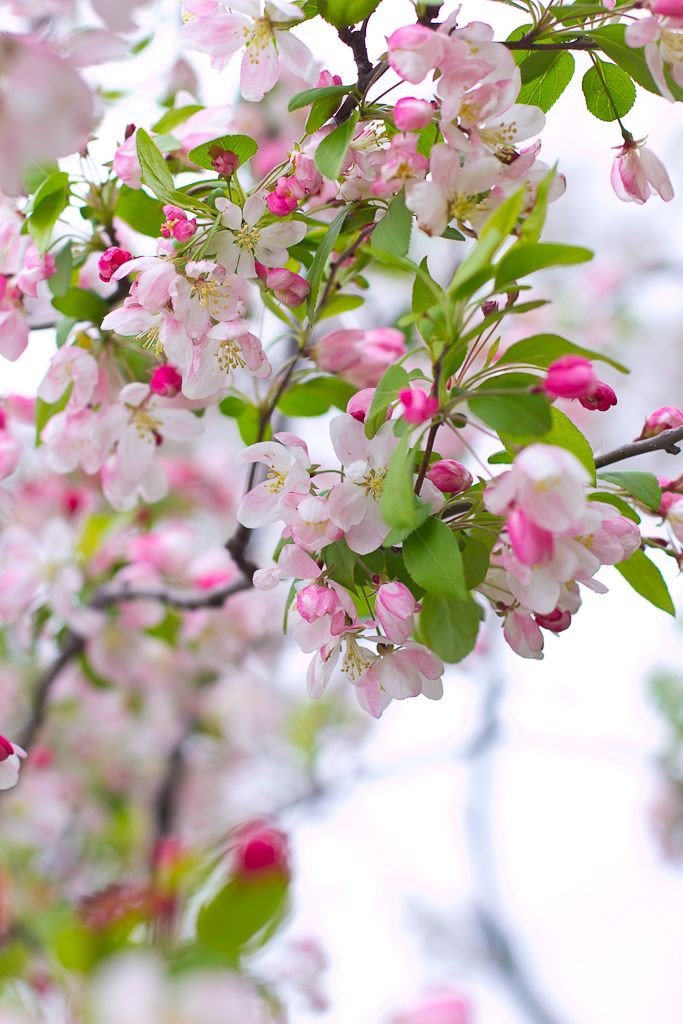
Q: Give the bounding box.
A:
[403,516,467,597]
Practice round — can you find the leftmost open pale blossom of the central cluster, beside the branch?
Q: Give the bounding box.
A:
[237,440,310,529]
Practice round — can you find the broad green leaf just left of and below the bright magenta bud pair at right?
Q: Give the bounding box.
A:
[468,374,552,437]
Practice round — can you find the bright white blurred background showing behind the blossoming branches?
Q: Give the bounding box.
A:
[0,0,683,1024]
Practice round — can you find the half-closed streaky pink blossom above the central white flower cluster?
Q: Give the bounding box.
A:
[311,327,407,388]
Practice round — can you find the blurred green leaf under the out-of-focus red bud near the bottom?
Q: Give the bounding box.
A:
[197,873,288,964]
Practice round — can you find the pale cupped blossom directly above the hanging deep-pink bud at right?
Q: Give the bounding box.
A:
[483,443,589,534]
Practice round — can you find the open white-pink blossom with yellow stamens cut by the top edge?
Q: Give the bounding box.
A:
[182,0,314,102]
